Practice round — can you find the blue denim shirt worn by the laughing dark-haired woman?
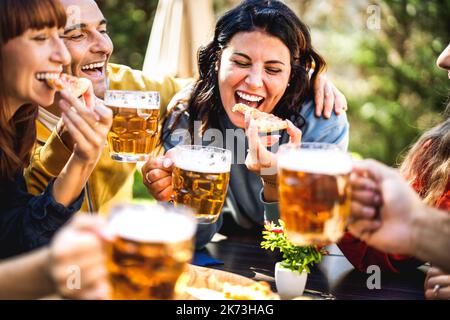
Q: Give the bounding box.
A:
[163,96,349,249]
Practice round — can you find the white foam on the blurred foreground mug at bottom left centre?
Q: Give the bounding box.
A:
[108,205,197,243]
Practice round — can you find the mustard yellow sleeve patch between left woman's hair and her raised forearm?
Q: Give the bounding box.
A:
[24,130,72,195]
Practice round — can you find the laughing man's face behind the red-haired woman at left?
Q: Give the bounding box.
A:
[62,0,113,98]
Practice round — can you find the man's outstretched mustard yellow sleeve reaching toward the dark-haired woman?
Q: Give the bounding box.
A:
[108,63,194,116]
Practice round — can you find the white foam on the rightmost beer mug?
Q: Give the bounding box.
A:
[278,149,352,175]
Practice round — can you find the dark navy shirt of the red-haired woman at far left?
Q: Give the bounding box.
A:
[0,171,84,259]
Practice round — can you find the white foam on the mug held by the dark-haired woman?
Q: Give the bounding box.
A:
[174,150,231,173]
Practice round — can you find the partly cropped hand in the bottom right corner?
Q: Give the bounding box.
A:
[424,267,450,300]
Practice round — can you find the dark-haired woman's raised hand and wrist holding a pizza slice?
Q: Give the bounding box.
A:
[245,115,302,202]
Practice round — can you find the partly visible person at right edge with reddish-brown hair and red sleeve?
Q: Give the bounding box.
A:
[338,45,450,299]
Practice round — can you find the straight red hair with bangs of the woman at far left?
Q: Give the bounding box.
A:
[0,0,66,182]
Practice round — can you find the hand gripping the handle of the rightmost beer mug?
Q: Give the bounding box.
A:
[348,160,425,255]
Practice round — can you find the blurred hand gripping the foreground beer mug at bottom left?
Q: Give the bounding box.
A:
[48,215,110,300]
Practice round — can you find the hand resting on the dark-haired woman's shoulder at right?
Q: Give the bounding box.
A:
[314,74,348,119]
